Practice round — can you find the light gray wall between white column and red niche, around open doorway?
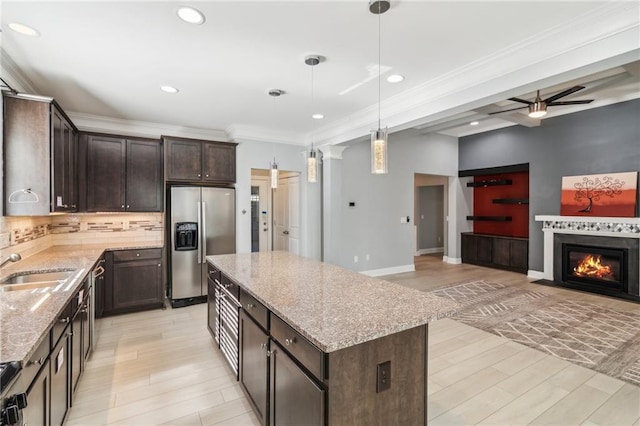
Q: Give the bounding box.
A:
[335,129,458,271]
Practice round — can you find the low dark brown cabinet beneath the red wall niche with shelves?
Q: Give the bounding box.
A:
[461,233,529,273]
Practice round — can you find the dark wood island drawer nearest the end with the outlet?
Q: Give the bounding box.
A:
[270,312,324,381]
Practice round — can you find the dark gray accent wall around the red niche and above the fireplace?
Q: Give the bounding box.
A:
[459,100,640,271]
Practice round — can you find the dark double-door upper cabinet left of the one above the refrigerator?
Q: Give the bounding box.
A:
[79,133,163,212]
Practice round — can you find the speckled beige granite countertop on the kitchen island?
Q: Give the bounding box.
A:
[207,251,460,352]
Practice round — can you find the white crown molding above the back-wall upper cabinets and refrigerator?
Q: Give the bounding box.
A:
[67,111,229,142]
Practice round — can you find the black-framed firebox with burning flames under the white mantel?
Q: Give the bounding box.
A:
[562,244,629,293]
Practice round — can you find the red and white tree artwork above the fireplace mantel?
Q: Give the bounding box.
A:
[560,172,638,217]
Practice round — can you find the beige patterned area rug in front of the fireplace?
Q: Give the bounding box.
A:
[430,281,640,386]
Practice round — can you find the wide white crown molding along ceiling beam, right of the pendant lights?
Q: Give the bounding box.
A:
[314,2,640,145]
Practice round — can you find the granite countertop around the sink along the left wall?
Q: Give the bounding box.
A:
[0,242,162,364]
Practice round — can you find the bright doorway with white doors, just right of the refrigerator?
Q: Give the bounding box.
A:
[251,169,300,254]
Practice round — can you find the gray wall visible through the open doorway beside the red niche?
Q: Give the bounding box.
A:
[415,185,444,250]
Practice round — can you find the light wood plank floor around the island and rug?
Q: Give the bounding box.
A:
[67,256,640,426]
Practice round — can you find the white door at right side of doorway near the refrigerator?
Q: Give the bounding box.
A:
[273,174,300,254]
